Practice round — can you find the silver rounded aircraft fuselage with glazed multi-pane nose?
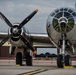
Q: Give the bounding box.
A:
[46,8,76,52]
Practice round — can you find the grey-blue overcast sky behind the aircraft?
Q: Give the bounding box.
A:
[0,0,76,54]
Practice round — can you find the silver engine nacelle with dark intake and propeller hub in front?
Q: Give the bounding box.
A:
[9,24,23,46]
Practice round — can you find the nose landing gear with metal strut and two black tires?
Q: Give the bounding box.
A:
[57,34,72,68]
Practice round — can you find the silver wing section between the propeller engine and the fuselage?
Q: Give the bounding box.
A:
[27,33,54,48]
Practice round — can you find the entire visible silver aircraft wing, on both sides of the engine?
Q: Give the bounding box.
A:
[0,32,54,48]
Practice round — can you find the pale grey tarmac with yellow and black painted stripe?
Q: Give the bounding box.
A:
[0,59,76,75]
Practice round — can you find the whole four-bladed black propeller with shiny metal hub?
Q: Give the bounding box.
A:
[0,9,38,51]
